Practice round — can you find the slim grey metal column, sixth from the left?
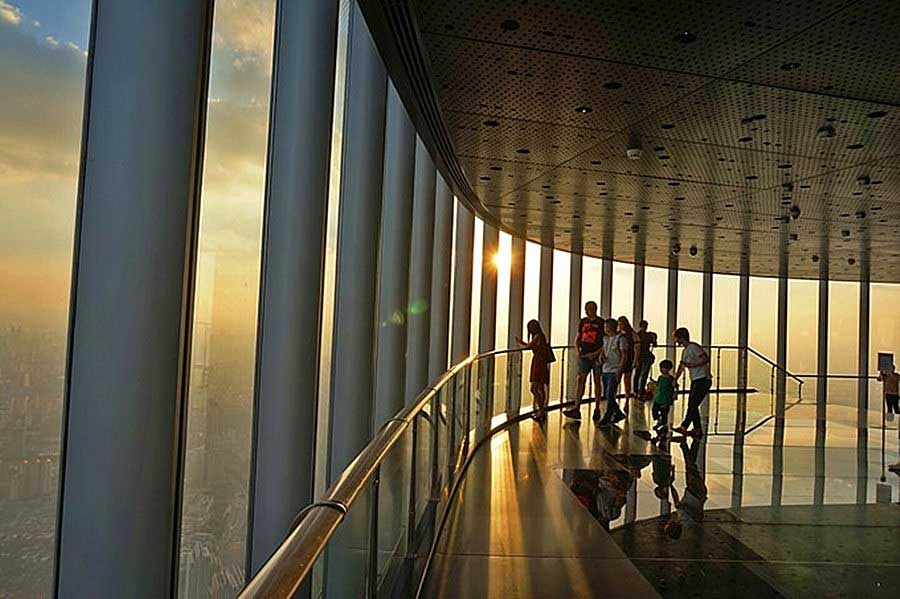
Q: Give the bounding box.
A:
[428,176,453,381]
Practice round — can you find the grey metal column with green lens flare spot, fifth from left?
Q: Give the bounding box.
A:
[406,139,438,405]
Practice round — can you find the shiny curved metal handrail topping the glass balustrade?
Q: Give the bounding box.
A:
[239,345,803,599]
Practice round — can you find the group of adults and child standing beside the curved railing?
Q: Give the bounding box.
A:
[519,301,712,437]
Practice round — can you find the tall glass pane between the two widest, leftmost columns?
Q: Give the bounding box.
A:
[178,0,275,597]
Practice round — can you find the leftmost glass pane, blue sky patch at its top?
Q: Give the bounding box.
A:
[0,0,92,597]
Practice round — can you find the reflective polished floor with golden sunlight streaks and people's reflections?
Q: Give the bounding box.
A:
[423,402,900,598]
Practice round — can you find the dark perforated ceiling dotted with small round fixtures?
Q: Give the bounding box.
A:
[412,0,900,282]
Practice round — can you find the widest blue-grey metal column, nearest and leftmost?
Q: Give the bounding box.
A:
[54,0,212,597]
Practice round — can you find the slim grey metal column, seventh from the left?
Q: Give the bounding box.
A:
[450,209,475,364]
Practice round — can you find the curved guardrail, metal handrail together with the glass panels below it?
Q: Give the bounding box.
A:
[240,346,802,599]
